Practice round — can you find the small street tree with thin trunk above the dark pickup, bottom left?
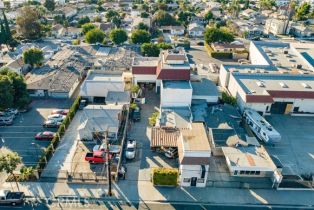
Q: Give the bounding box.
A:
[0,152,22,191]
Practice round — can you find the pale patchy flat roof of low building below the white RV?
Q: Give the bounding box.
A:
[222,146,277,171]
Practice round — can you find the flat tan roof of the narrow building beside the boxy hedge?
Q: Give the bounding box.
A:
[181,123,210,152]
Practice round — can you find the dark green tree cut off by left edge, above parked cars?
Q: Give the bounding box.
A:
[0,75,14,110]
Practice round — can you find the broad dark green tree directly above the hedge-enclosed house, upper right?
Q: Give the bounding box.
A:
[204,27,234,44]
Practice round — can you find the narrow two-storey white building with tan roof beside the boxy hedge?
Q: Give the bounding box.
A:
[178,123,211,187]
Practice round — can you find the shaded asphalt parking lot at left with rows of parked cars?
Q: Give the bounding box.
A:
[0,99,71,166]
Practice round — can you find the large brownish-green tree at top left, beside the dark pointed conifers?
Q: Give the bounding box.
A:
[16,6,42,39]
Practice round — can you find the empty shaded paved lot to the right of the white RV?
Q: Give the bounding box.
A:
[266,115,314,175]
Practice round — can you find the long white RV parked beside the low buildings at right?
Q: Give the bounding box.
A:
[243,109,281,144]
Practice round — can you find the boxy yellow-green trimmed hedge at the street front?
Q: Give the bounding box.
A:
[152,168,179,186]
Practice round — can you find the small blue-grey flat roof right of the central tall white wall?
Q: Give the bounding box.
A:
[191,78,219,96]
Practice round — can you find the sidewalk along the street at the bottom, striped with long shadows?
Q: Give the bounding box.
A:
[3,180,314,207]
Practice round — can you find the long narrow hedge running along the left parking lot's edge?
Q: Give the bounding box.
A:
[36,97,80,174]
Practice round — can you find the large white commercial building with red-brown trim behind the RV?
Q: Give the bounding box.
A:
[219,42,314,115]
